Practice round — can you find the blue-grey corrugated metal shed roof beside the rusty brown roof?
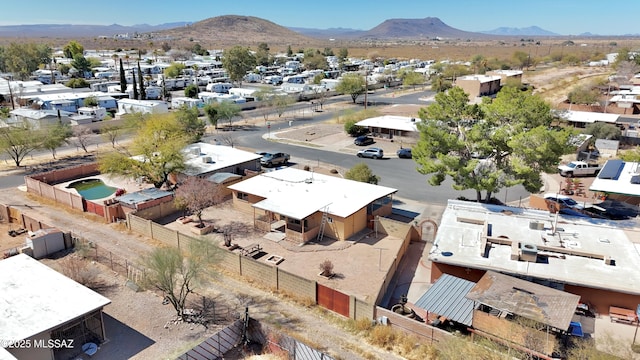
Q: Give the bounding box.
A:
[415,274,476,326]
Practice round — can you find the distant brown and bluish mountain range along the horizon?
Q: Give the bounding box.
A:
[0,15,604,44]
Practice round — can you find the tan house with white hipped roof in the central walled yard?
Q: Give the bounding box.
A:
[229,168,398,244]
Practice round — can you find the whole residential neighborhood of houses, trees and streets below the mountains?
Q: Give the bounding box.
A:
[0,7,640,360]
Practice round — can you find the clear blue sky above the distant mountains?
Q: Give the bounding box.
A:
[0,0,640,35]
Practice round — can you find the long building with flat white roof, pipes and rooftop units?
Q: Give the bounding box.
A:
[429,201,640,315]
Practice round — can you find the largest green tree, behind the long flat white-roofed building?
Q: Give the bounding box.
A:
[413,86,571,201]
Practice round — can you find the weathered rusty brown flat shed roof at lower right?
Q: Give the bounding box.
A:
[467,271,580,330]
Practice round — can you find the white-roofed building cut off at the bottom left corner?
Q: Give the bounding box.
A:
[0,254,111,360]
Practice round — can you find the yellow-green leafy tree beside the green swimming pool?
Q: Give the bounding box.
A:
[98,114,188,188]
